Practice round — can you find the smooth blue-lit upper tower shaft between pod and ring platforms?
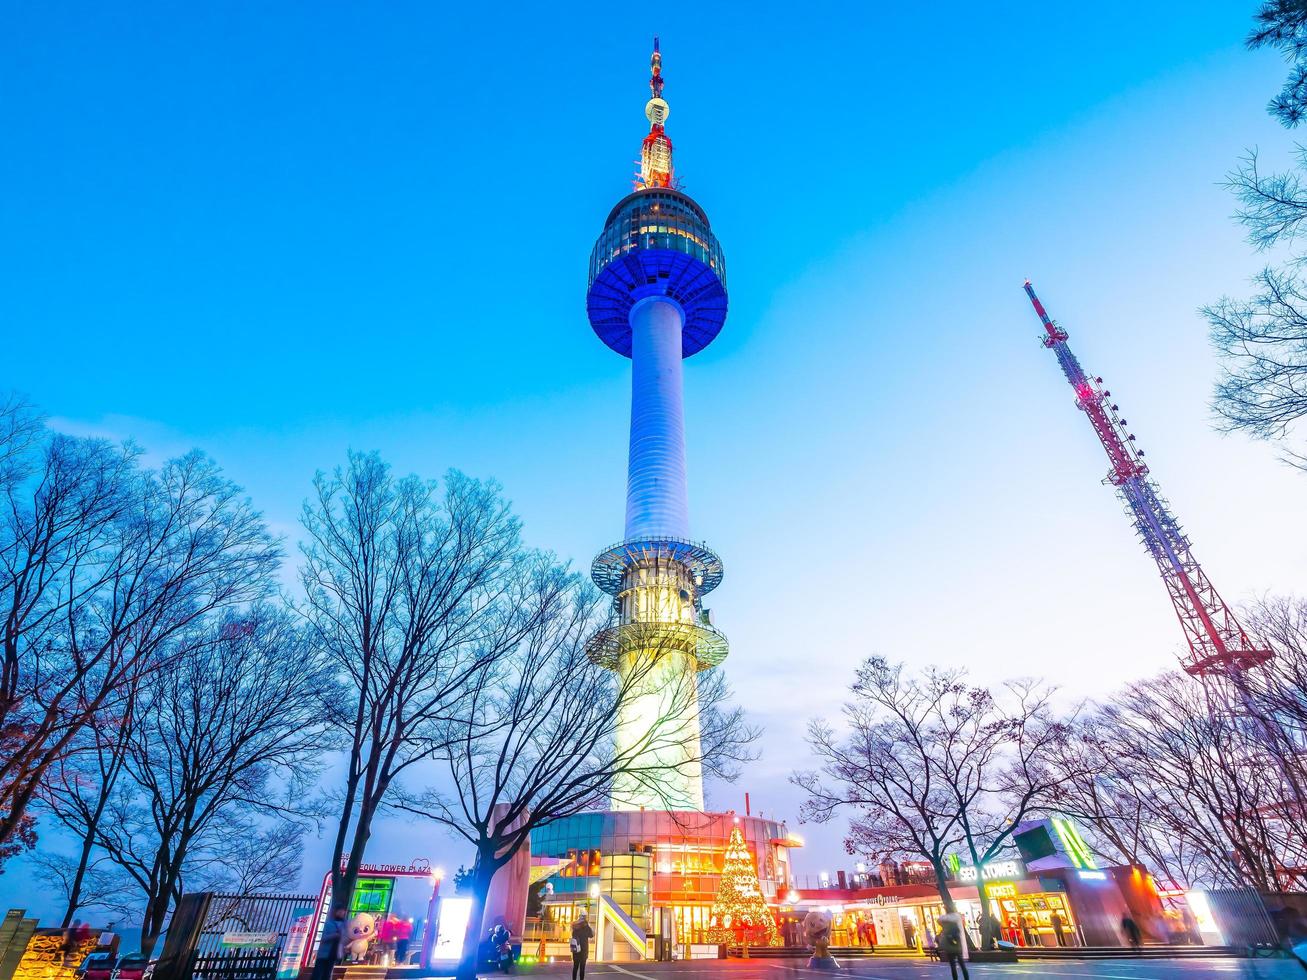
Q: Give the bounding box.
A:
[626,295,690,540]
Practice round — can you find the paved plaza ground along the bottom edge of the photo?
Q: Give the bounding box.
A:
[499,958,1307,980]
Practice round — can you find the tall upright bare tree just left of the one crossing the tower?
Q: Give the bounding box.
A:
[301,453,527,902]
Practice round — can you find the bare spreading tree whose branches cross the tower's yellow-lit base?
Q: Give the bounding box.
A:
[396,582,755,977]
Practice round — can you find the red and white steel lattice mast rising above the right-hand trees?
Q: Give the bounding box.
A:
[1026,280,1272,677]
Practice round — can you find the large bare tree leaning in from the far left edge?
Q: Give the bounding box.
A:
[0,435,280,857]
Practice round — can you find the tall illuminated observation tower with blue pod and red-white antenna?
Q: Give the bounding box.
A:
[586,38,727,810]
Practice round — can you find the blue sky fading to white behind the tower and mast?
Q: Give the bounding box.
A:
[0,0,1307,911]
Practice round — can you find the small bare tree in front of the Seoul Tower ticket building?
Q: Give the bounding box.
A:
[793,657,1065,909]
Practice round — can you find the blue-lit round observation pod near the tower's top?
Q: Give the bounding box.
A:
[586,187,727,357]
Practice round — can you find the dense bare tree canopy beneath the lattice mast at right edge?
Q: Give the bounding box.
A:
[1055,598,1307,891]
